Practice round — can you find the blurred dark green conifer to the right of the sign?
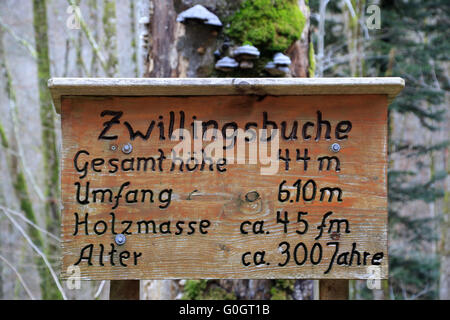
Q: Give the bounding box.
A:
[372,0,450,299]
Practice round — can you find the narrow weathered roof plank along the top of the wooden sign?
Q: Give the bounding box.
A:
[48,77,405,113]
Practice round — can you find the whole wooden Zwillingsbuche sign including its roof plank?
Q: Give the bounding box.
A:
[49,78,403,280]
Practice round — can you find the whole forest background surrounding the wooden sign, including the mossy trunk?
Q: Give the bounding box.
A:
[0,0,450,299]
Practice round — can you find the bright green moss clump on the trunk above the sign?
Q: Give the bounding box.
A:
[225,0,306,53]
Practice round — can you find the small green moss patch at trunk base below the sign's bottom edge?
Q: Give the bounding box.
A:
[182,280,236,300]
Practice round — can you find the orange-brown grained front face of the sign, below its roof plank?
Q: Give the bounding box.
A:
[61,94,388,280]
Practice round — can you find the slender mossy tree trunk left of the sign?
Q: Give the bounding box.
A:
[33,0,62,299]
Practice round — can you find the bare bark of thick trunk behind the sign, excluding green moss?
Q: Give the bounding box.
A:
[143,0,314,299]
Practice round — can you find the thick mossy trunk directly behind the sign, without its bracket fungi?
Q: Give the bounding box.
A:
[145,0,314,299]
